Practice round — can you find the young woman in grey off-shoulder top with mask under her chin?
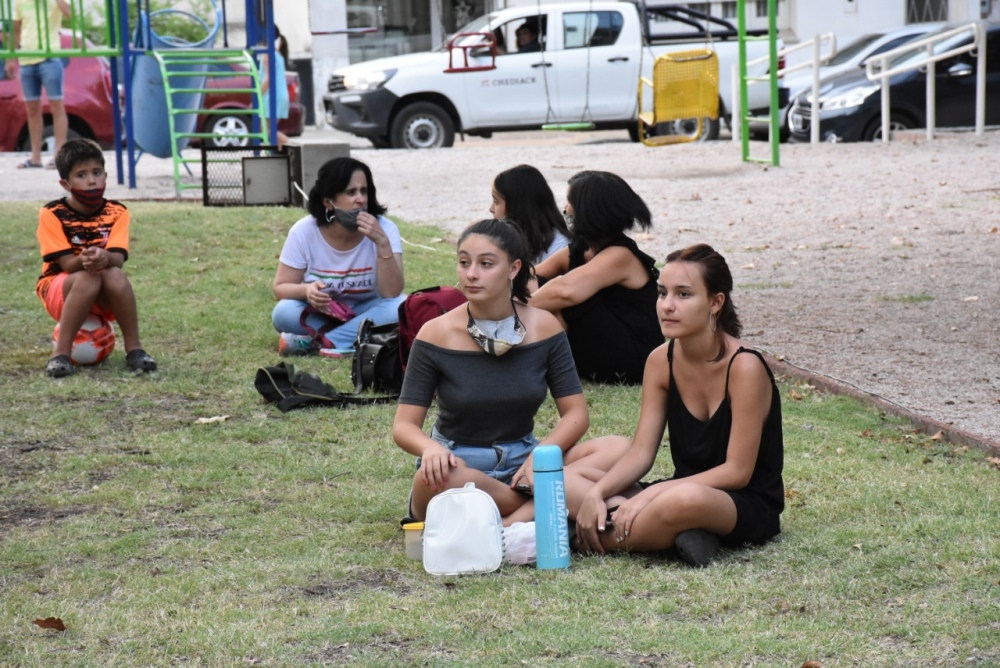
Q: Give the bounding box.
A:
[392,219,620,524]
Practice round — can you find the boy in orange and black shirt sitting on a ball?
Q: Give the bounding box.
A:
[35,139,156,378]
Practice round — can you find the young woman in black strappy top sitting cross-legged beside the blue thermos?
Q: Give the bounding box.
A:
[566,244,785,566]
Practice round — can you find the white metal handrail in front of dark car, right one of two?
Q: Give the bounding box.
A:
[865,22,986,142]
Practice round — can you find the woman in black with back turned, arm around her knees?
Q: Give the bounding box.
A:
[531,171,663,385]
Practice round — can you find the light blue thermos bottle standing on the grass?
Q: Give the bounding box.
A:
[533,445,569,569]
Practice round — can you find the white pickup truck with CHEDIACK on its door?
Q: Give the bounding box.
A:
[323,0,769,148]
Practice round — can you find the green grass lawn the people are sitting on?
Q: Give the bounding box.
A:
[0,203,1000,668]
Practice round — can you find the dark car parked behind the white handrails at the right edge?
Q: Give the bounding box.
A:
[788,24,1000,141]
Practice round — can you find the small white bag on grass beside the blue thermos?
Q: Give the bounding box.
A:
[424,482,503,575]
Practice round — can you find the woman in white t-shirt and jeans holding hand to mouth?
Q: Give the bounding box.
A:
[271,158,404,357]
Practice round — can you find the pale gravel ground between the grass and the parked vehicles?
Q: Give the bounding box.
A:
[0,132,1000,443]
